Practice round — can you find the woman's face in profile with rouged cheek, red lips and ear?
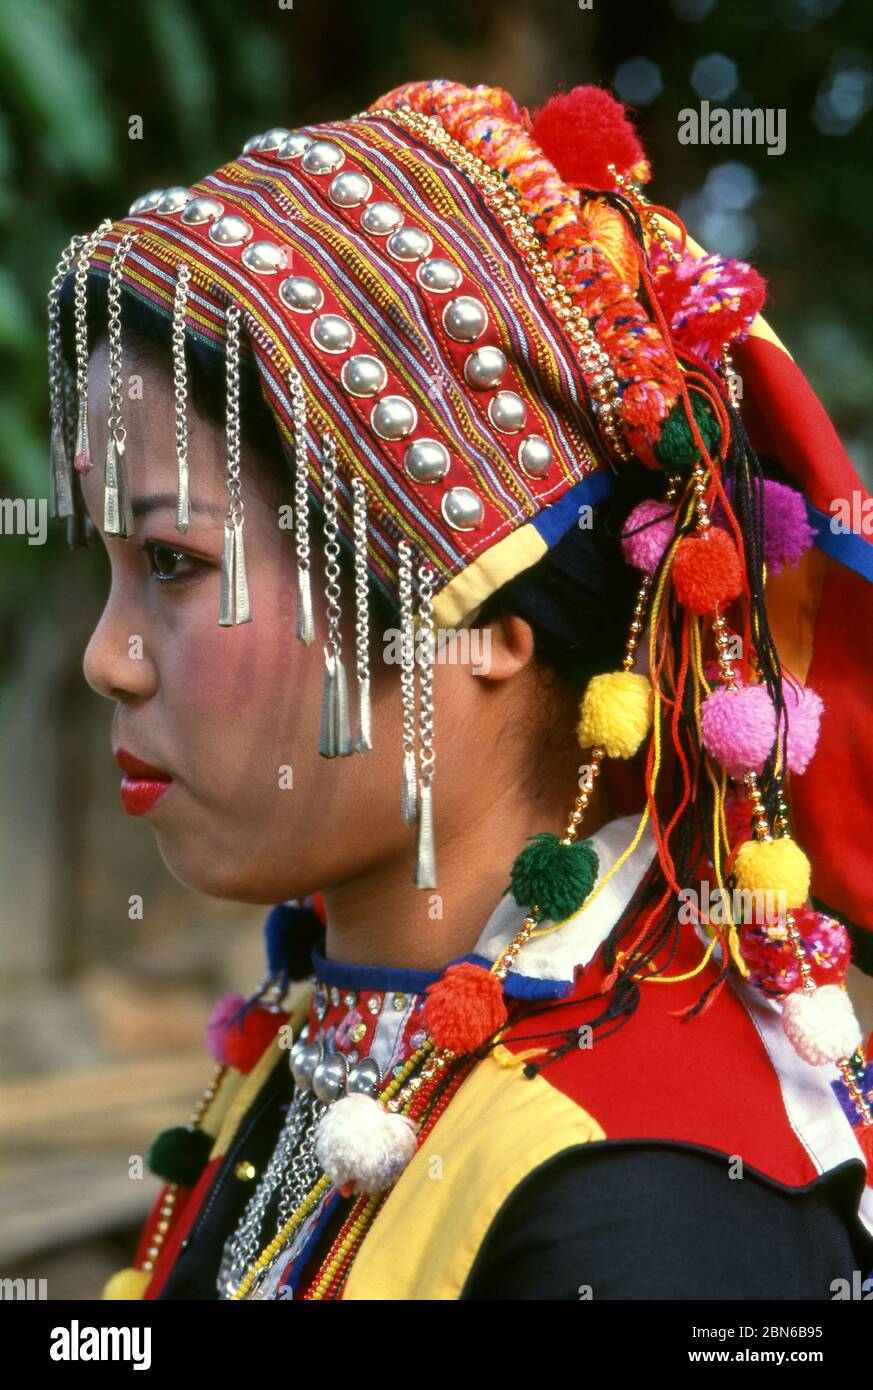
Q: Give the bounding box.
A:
[83,332,542,902]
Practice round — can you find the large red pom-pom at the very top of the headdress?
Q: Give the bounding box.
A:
[531,86,648,188]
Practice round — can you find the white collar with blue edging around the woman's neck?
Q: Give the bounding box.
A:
[311,813,655,999]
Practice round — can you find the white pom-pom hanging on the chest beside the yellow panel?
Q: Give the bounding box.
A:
[316,1095,418,1194]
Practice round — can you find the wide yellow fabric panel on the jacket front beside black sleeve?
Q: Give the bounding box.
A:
[343,1047,606,1301]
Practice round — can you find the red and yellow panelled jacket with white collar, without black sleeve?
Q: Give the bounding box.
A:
[123,817,873,1300]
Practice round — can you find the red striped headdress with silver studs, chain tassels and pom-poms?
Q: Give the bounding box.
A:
[50,81,873,1251]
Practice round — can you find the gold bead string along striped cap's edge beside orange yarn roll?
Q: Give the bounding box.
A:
[372,107,630,459]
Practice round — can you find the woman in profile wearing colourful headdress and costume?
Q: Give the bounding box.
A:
[50,81,873,1300]
